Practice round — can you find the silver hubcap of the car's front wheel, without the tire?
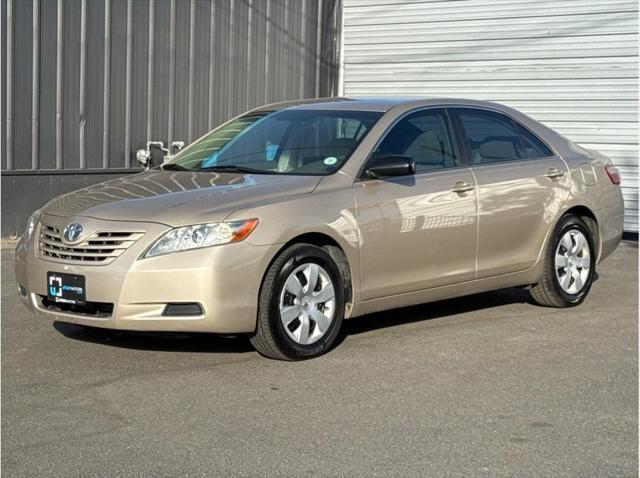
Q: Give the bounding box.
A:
[279,263,336,345]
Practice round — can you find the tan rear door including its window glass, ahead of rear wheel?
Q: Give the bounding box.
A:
[452,108,568,278]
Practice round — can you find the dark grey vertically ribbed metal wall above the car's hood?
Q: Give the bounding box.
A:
[0,0,340,172]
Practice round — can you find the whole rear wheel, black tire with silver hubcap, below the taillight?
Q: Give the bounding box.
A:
[531,214,596,307]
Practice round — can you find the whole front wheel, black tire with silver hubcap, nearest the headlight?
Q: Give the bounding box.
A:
[250,244,346,360]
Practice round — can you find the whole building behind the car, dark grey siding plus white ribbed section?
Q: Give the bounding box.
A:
[0,0,638,237]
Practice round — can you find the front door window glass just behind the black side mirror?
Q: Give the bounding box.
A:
[373,110,458,172]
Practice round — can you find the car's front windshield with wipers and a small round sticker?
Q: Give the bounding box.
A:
[168,110,382,175]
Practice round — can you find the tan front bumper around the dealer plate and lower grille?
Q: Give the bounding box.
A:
[15,216,279,333]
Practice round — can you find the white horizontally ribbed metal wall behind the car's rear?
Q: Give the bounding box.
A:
[343,0,638,231]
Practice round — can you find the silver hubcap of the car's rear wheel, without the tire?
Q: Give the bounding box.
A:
[555,229,591,294]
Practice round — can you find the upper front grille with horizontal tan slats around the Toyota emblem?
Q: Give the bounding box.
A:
[38,224,143,264]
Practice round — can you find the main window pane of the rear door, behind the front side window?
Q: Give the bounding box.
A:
[455,108,526,165]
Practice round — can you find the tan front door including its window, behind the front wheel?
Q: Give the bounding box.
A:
[354,109,476,300]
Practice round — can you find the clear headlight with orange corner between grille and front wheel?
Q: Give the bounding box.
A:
[144,219,258,257]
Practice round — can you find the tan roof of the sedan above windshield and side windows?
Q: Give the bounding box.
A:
[254,96,504,113]
